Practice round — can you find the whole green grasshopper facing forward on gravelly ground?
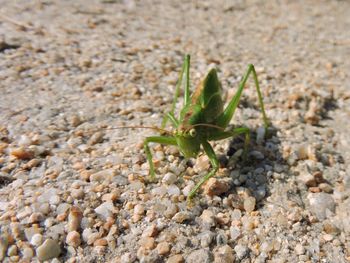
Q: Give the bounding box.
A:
[144,55,269,200]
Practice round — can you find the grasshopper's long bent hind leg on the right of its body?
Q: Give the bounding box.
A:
[217,64,269,129]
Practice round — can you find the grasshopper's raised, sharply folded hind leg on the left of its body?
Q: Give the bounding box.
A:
[161,55,190,128]
